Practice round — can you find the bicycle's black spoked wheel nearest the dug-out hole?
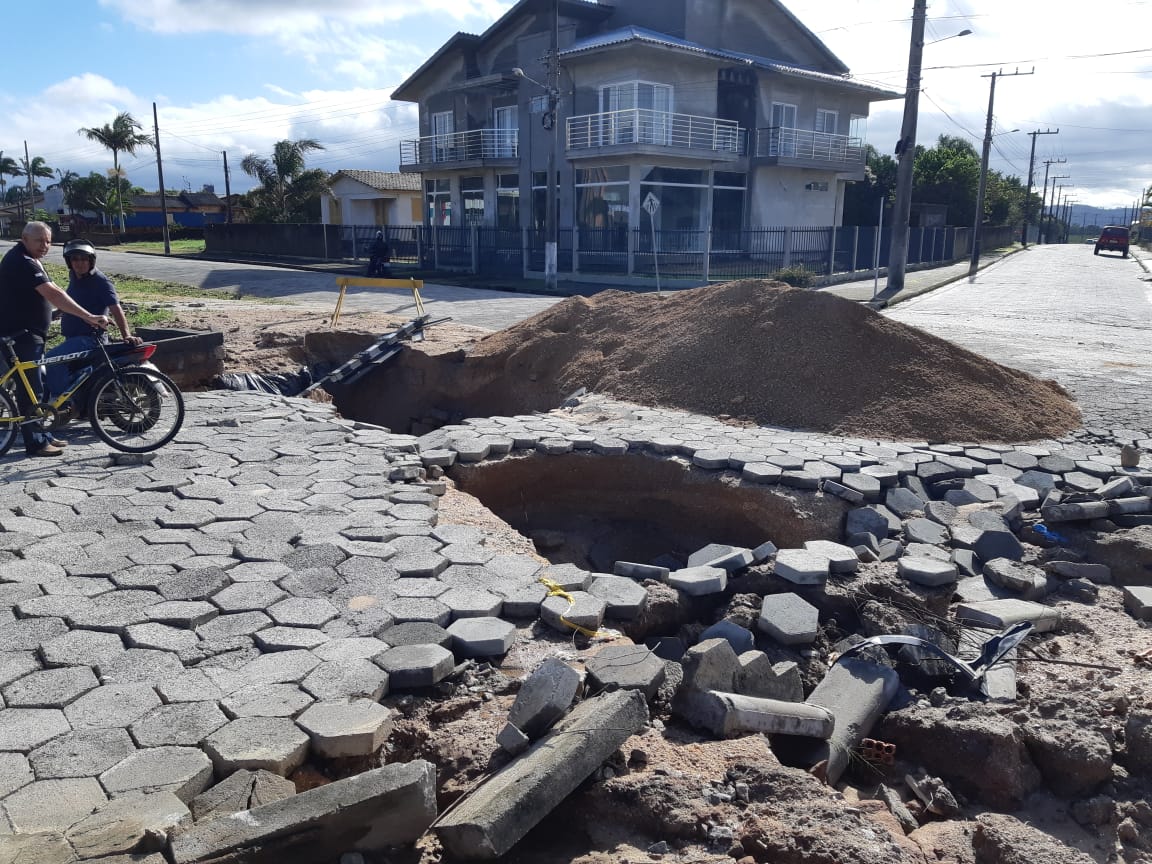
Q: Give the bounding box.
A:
[88,369,184,453]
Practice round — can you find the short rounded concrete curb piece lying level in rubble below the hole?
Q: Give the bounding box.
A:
[676,690,835,740]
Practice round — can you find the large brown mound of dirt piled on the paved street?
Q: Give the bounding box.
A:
[469,280,1079,441]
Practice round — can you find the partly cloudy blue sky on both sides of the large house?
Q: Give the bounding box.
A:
[0,0,1152,216]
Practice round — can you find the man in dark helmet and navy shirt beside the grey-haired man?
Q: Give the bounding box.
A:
[44,240,141,395]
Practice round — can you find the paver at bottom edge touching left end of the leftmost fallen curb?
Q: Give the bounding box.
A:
[65,791,190,858]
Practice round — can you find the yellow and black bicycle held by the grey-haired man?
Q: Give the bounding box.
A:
[0,336,184,456]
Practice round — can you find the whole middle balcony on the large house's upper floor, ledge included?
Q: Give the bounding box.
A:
[566,108,746,161]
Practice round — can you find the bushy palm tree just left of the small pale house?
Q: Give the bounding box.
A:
[240,138,328,222]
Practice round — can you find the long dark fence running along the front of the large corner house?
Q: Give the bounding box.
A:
[204,225,1016,281]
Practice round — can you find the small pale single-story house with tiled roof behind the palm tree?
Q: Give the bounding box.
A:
[320,169,423,225]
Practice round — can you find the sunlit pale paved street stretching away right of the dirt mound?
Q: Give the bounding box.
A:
[886,245,1152,446]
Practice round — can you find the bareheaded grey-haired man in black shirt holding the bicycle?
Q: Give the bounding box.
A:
[0,222,109,456]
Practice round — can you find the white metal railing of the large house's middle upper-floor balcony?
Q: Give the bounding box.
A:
[568,108,745,156]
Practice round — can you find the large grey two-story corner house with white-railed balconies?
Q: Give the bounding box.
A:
[393,0,901,245]
